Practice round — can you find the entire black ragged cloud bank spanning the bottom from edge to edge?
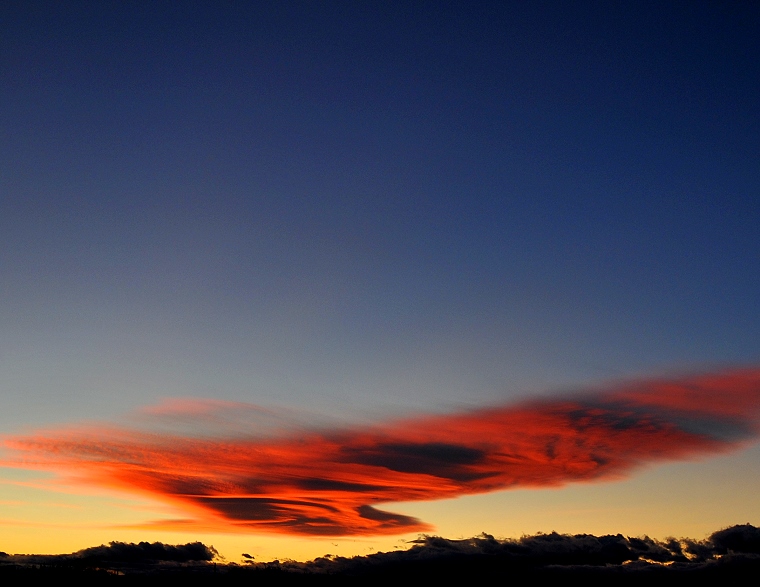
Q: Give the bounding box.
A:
[0,524,760,583]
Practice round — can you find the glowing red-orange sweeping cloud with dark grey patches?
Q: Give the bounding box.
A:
[5,370,760,535]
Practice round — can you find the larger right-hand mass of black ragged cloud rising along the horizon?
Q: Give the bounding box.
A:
[252,524,760,579]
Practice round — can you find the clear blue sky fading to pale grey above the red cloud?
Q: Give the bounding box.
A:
[0,2,760,432]
